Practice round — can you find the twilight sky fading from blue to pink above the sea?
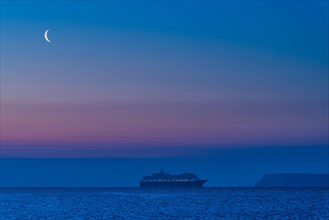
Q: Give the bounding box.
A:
[0,1,329,186]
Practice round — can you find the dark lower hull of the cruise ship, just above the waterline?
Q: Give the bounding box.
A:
[139,180,207,187]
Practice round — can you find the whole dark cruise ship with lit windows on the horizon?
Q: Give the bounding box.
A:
[139,170,207,187]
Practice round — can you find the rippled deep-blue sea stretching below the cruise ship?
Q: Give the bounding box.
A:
[0,187,329,220]
